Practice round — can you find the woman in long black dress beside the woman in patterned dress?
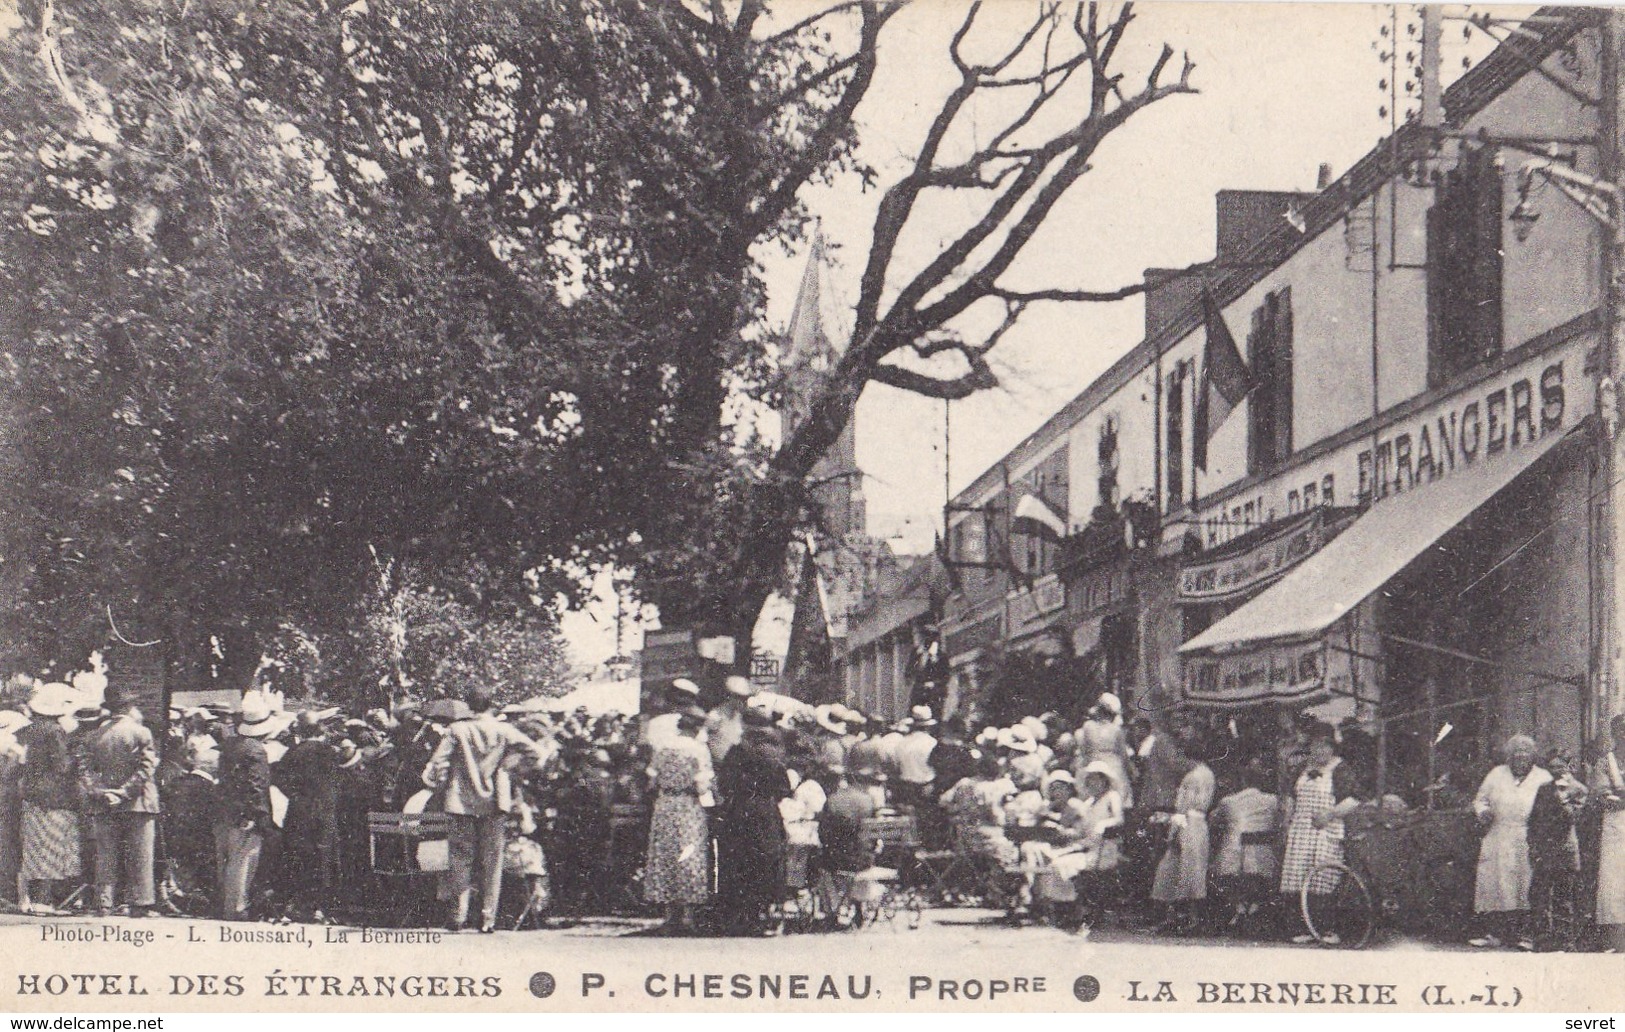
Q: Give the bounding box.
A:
[713,709,790,934]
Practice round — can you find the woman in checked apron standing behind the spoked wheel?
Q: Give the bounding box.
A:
[1281,723,1360,943]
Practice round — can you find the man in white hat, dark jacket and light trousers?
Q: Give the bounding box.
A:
[215,692,283,921]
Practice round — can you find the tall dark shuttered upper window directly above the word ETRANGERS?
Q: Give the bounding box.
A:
[1427,148,1502,387]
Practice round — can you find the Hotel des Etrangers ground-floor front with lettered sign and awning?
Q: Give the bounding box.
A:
[1180,340,1593,806]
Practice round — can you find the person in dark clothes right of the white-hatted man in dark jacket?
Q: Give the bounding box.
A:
[271,710,340,921]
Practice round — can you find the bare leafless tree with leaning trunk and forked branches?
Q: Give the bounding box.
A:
[692,3,1194,653]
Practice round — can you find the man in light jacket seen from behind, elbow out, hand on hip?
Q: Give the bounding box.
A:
[423,691,556,933]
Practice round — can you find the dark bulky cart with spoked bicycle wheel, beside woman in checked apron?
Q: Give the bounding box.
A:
[1298,808,1477,949]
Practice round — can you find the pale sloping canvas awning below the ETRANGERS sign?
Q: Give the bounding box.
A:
[1180,432,1565,694]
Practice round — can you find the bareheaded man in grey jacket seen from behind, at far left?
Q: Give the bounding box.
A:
[85,699,158,915]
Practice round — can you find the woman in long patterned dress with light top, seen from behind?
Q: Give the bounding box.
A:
[644,705,715,933]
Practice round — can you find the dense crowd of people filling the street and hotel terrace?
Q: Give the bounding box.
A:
[0,678,1625,949]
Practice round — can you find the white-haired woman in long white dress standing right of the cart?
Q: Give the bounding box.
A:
[1469,735,1552,949]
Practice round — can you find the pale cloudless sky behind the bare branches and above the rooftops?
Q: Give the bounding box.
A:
[566,0,1521,660]
